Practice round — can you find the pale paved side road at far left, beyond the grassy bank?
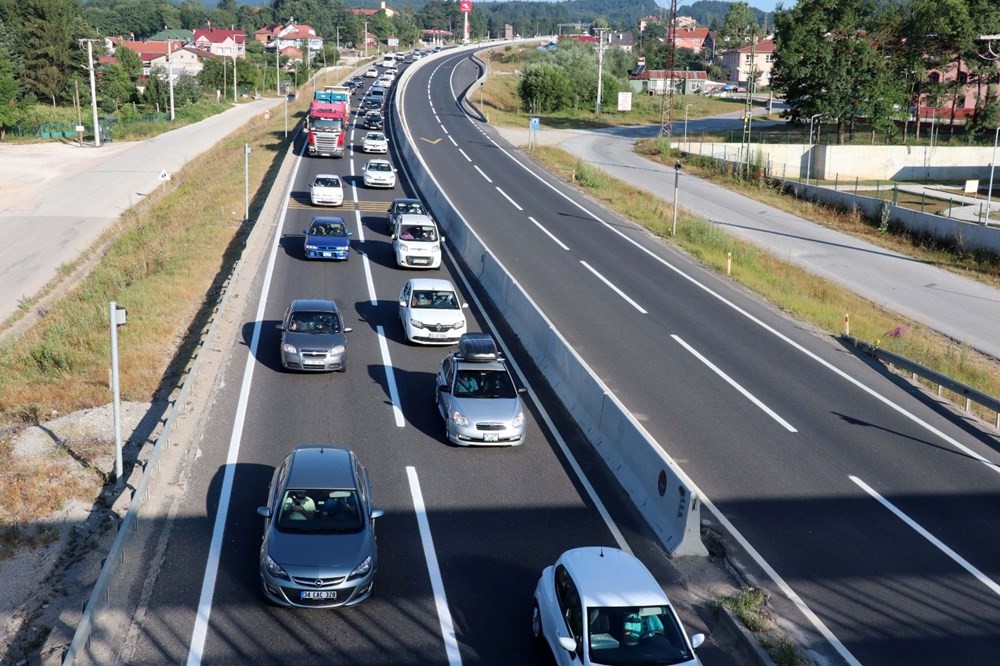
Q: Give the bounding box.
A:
[0,98,282,321]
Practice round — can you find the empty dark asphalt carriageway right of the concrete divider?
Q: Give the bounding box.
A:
[397,49,1000,664]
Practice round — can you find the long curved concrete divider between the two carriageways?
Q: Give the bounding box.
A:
[389,49,708,556]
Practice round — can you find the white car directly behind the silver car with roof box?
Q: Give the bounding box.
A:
[399,278,469,345]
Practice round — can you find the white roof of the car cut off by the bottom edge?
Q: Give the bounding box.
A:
[557,546,670,607]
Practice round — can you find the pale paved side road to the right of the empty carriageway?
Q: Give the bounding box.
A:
[499,119,1000,358]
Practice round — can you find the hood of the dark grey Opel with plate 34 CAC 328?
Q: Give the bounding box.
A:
[267,528,373,576]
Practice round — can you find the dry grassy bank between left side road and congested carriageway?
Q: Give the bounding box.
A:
[0,70,320,559]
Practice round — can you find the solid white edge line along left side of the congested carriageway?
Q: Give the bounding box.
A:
[187,131,302,666]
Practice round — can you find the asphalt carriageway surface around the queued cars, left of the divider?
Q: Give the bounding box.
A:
[121,54,737,666]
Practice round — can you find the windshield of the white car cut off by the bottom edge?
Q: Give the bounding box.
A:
[587,606,694,666]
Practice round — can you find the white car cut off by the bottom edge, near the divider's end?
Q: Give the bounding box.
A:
[531,546,705,666]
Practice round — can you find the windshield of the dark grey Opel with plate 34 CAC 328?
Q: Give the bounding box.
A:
[276,489,365,534]
